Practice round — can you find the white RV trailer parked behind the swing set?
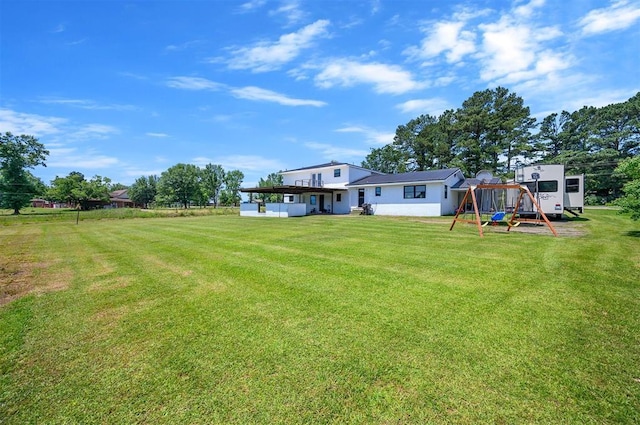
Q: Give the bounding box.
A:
[514,164,584,218]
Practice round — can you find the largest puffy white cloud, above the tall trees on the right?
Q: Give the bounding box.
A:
[400,0,575,88]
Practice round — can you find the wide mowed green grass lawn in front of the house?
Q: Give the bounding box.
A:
[0,210,640,424]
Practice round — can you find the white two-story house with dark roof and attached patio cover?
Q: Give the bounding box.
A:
[240,162,464,217]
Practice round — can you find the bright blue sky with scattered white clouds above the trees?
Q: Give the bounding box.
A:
[0,0,640,186]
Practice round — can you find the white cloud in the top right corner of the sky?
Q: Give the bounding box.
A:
[579,0,640,35]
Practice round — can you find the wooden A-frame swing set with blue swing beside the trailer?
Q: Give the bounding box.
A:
[449,183,558,237]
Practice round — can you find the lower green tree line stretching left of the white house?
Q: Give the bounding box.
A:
[0,132,244,214]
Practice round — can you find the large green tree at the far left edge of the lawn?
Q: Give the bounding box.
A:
[0,132,49,215]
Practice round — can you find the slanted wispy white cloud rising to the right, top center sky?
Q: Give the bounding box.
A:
[228,19,329,72]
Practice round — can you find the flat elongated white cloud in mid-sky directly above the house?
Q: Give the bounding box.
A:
[315,59,425,94]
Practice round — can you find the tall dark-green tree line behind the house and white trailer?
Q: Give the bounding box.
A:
[362,87,640,204]
